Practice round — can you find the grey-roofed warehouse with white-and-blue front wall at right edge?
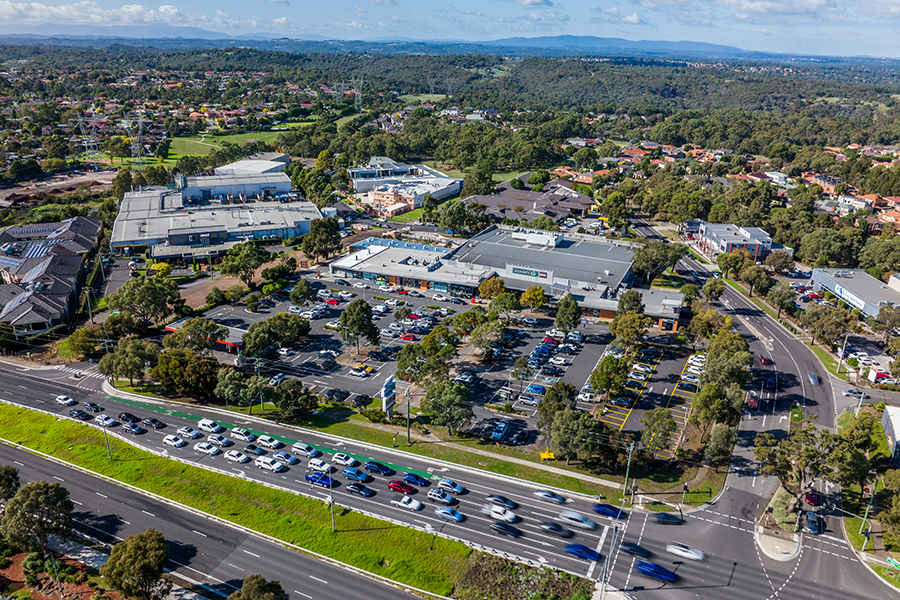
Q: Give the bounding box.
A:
[810,269,900,318]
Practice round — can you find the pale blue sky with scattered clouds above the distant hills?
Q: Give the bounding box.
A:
[0,0,900,57]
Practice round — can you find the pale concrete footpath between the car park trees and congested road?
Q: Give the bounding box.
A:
[103,381,624,490]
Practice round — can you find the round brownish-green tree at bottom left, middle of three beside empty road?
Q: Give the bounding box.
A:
[100,529,172,600]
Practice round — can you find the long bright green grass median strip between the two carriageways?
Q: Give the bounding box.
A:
[0,405,473,595]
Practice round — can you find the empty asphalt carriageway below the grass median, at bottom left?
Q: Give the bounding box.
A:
[0,444,418,600]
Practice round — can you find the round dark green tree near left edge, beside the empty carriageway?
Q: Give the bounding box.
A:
[0,481,74,554]
